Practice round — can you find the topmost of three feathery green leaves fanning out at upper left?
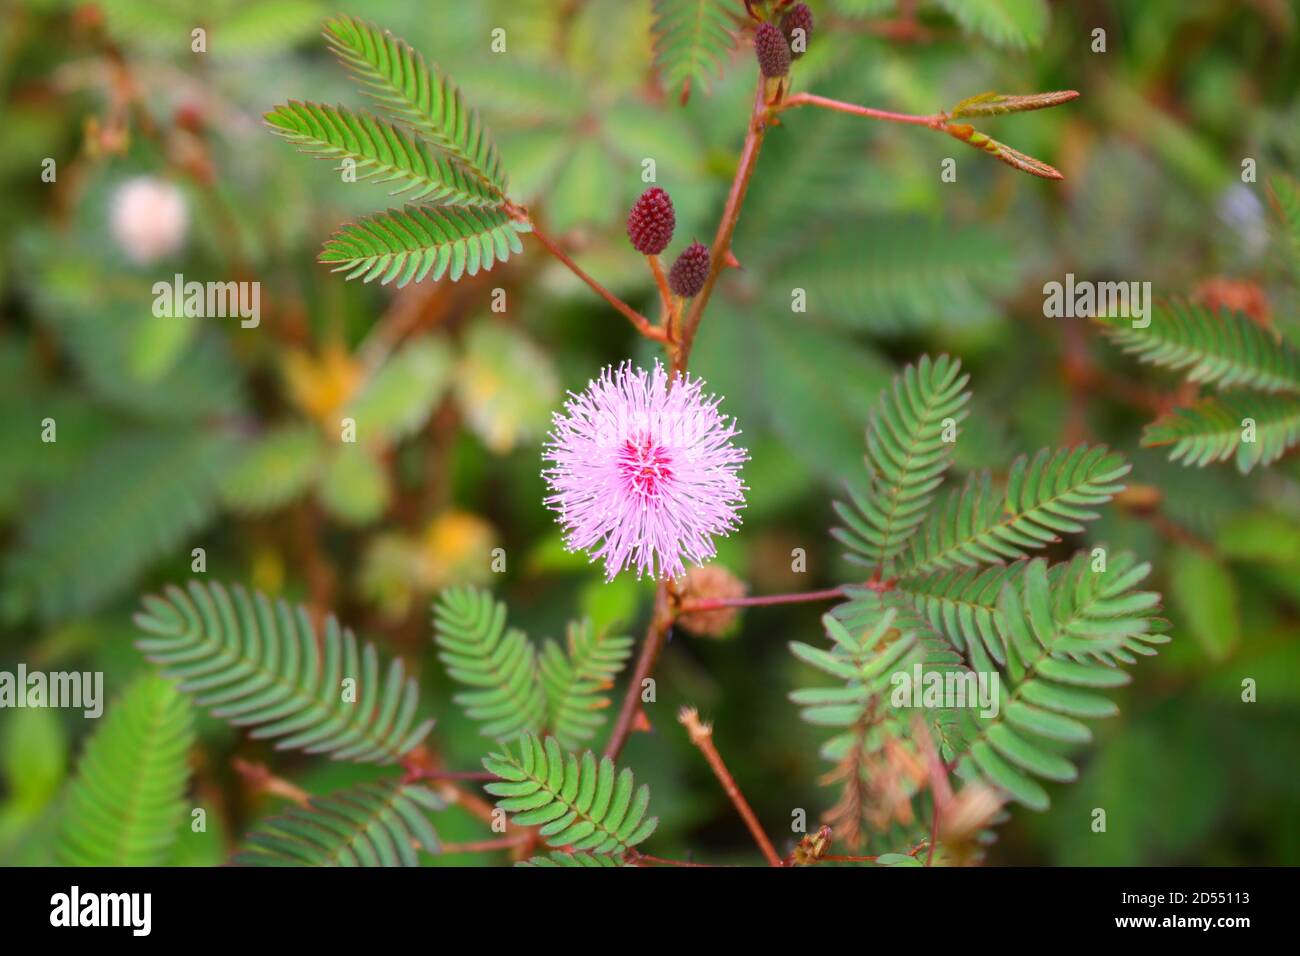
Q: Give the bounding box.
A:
[325,17,506,199]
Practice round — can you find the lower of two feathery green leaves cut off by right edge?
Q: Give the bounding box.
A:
[1141,393,1300,475]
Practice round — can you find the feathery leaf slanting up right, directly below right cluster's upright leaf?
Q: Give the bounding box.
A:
[900,445,1130,574]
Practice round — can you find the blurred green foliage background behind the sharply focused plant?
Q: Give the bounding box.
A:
[0,0,1300,865]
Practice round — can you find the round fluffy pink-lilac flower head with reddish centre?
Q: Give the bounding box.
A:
[542,362,748,580]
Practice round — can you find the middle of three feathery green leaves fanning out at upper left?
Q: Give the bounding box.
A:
[265,100,502,206]
